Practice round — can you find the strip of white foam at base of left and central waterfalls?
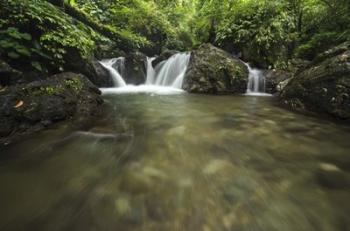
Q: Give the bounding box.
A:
[100,85,186,95]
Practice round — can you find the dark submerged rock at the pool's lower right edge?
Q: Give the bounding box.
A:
[316,163,350,189]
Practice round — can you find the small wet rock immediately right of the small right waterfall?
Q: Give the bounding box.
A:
[264,70,292,94]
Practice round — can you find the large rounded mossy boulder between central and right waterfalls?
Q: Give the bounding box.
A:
[183,44,248,94]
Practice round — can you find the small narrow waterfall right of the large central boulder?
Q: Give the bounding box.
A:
[245,63,265,95]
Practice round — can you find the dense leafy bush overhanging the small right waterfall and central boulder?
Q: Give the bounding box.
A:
[216,1,294,66]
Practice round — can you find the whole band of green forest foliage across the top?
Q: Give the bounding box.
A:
[0,0,350,73]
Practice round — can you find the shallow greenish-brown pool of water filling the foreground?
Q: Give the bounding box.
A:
[0,94,350,231]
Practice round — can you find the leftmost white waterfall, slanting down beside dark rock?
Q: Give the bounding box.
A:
[100,57,126,87]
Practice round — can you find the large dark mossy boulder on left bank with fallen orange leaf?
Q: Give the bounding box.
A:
[0,73,103,144]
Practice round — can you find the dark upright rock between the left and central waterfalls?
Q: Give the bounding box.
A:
[122,52,147,85]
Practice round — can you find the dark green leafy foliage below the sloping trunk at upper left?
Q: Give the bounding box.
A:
[0,0,109,72]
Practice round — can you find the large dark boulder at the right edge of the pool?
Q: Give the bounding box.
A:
[280,43,350,119]
